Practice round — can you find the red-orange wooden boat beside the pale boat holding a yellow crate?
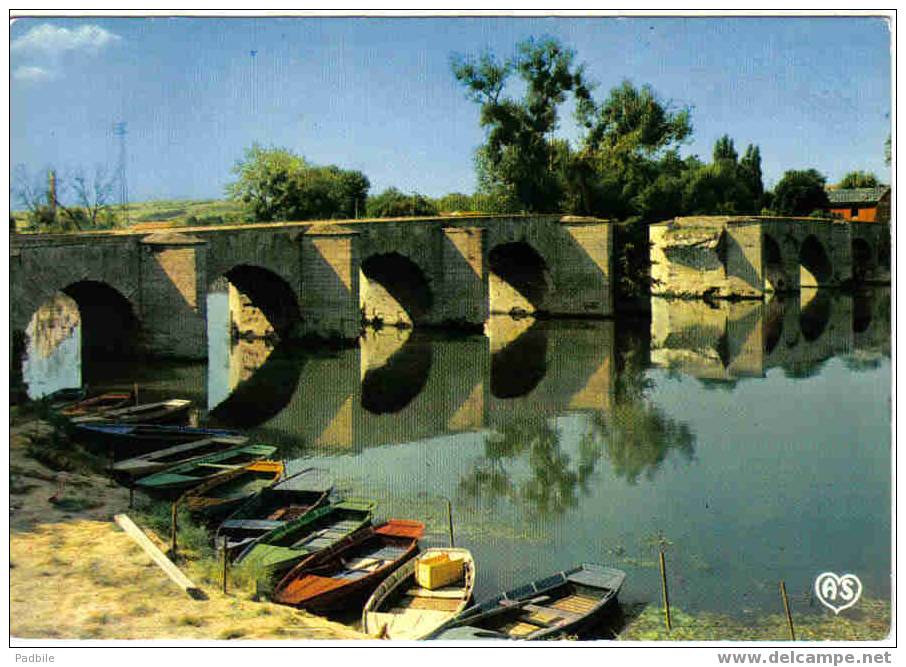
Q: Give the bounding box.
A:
[273,519,425,613]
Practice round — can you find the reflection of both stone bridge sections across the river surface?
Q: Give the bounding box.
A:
[23,288,891,434]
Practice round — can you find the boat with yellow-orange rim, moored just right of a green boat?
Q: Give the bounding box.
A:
[180,461,284,520]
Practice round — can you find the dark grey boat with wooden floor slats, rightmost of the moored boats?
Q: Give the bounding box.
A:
[428,563,626,640]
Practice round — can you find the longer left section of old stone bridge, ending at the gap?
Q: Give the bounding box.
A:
[10,215,613,359]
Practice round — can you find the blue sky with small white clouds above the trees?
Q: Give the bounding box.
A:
[10,17,891,201]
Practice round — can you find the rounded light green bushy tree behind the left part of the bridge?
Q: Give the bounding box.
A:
[226,144,370,221]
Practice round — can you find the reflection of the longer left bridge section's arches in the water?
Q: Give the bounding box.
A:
[208,317,614,452]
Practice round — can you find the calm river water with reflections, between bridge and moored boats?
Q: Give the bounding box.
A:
[23,289,891,615]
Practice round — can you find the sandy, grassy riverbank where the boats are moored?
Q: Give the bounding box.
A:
[10,422,364,640]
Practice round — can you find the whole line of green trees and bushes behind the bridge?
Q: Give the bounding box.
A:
[13,37,890,235]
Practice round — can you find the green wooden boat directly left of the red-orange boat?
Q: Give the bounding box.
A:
[236,500,374,579]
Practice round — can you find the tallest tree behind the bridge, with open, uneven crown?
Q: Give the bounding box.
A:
[452,38,591,211]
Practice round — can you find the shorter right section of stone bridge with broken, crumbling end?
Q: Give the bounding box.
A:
[649,216,890,298]
